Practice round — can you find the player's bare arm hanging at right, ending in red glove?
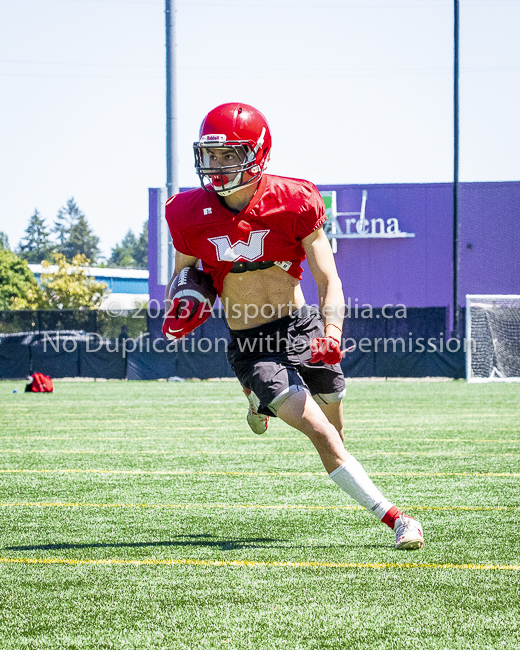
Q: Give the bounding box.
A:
[302,228,345,364]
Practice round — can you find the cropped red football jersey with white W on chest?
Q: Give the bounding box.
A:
[166,174,327,295]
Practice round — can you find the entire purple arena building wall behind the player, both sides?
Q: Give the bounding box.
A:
[148,181,520,307]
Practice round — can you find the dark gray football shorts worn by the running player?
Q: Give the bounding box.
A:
[227,305,345,416]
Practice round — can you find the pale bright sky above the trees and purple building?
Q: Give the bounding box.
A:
[0,0,520,255]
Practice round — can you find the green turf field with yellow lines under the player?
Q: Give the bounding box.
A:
[0,381,520,650]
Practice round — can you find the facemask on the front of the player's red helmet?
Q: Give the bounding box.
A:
[193,129,267,196]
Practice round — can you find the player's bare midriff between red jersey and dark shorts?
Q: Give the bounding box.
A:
[220,266,305,330]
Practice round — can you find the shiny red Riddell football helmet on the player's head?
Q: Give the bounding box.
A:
[193,102,271,196]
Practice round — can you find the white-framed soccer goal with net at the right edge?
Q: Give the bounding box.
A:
[466,295,520,382]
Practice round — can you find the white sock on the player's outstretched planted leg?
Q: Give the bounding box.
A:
[329,456,393,519]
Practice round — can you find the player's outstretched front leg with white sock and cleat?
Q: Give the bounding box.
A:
[271,391,424,550]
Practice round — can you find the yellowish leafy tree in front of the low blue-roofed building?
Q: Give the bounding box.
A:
[40,252,107,309]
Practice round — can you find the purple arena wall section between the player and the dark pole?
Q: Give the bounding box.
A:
[303,184,452,307]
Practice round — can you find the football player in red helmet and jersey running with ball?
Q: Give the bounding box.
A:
[163,103,424,549]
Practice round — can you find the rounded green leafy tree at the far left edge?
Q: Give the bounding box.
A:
[0,250,43,309]
